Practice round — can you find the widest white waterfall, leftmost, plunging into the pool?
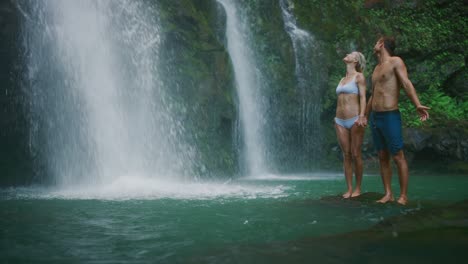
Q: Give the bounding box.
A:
[18,0,196,186]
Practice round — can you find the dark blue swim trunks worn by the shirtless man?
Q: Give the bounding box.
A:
[370,109,403,155]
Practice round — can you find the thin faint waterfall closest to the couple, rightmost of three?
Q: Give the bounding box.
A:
[279,0,323,166]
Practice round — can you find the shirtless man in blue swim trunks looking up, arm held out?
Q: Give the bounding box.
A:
[366,37,429,205]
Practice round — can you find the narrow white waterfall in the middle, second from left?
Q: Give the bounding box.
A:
[217,0,268,176]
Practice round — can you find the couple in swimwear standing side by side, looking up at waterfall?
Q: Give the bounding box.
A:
[335,37,429,205]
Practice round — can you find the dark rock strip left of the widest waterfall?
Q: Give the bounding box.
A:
[0,1,33,184]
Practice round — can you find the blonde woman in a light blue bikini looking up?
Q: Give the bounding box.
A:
[335,51,367,198]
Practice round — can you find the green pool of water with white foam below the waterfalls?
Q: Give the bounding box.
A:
[0,173,468,263]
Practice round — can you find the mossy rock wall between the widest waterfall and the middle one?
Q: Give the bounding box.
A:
[158,0,237,177]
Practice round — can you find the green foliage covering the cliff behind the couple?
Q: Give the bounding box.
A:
[294,0,468,126]
